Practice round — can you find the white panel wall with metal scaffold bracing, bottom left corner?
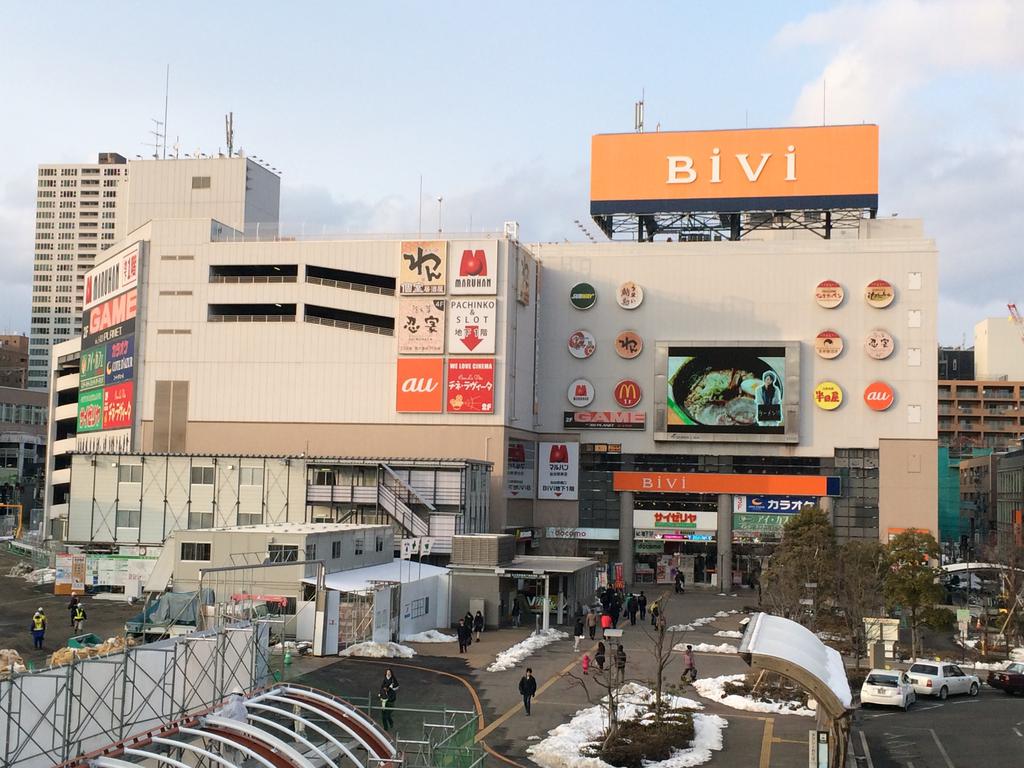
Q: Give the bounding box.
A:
[0,622,270,768]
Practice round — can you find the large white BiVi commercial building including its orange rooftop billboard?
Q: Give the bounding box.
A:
[51,126,938,602]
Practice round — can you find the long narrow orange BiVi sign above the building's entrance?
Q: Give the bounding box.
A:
[611,472,842,496]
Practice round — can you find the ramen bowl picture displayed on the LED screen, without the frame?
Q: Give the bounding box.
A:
[667,347,785,434]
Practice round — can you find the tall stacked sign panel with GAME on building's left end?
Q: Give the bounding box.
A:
[76,243,144,453]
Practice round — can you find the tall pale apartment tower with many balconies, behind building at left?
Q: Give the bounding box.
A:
[28,153,128,389]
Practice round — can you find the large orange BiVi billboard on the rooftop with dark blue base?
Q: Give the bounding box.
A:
[590,125,879,215]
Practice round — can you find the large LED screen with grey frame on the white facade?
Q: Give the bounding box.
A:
[655,342,800,442]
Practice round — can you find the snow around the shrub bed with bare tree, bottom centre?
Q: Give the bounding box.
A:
[526,683,728,768]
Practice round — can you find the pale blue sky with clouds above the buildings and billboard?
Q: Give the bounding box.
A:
[0,0,1024,344]
